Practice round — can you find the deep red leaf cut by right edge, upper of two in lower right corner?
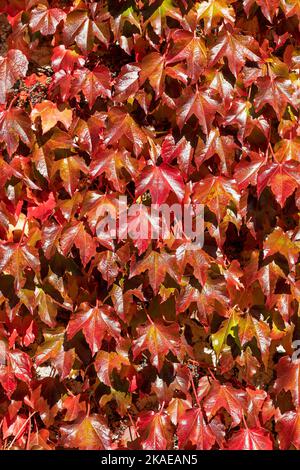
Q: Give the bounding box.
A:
[274,356,300,408]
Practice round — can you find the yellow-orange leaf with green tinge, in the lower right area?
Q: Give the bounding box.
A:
[239,313,271,368]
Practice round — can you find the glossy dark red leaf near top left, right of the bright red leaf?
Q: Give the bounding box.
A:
[63,9,110,54]
